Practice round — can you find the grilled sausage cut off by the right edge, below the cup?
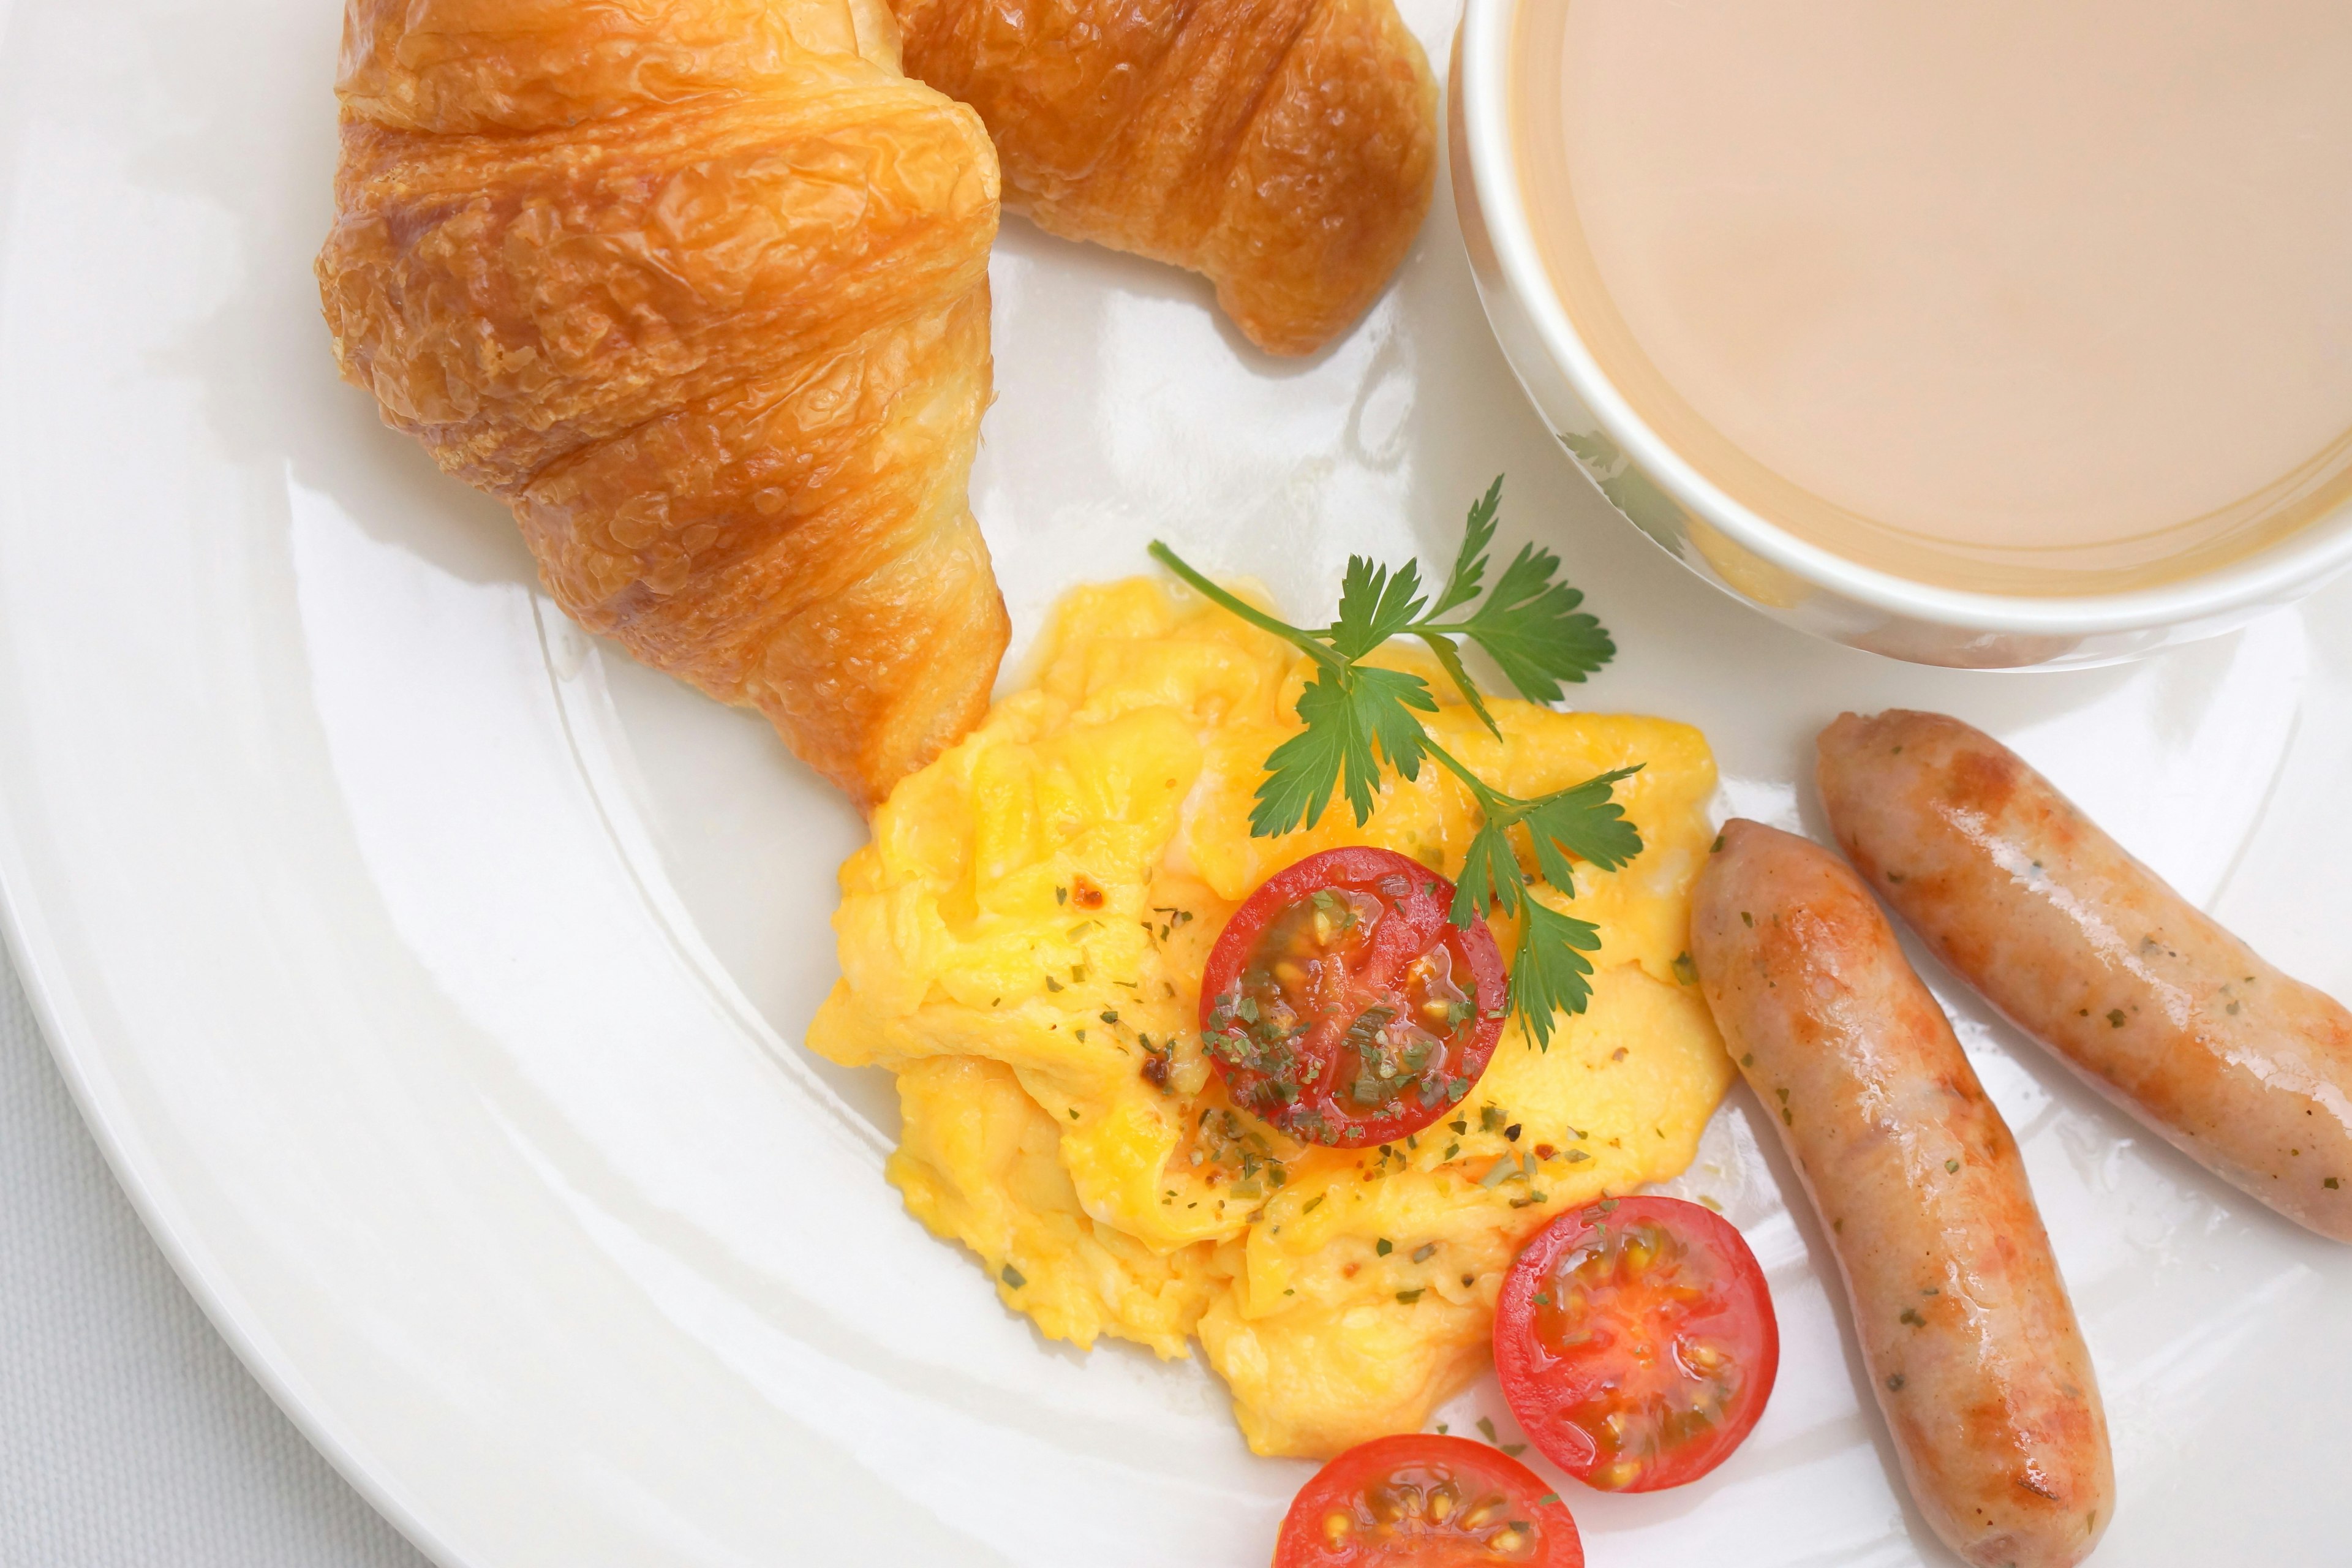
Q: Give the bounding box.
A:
[1820,710,2352,1242]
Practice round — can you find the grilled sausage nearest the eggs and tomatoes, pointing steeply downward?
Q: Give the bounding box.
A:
[1691,820,2114,1568]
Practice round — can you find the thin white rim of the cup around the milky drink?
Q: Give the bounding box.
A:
[1453,0,2352,635]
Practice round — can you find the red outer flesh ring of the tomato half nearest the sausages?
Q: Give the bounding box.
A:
[1493,1197,1781,1493]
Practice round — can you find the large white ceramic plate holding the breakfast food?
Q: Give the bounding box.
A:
[0,0,2352,1568]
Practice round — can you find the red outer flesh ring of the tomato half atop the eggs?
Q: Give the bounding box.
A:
[1199,846,1510,1150]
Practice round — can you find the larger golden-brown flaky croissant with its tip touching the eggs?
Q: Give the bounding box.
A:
[317,0,1007,809]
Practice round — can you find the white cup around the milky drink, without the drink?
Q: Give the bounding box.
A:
[1447,0,2352,670]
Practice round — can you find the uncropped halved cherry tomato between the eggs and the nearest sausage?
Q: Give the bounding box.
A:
[1493,1197,1781,1493]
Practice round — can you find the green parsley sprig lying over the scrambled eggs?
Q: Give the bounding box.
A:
[1153,477,1642,1049]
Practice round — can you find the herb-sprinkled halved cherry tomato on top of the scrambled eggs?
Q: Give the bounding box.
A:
[1199,849,1507,1150]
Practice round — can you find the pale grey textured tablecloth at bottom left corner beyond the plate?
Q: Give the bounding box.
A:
[0,944,426,1568]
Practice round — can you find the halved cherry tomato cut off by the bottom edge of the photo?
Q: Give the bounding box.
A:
[1275,1431,1585,1568]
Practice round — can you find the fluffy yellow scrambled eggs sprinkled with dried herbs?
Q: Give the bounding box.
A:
[809,581,1731,1458]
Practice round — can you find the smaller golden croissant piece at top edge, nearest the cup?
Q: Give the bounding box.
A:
[891,0,1437,355]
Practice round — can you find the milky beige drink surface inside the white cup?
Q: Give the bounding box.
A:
[1512,0,2352,592]
